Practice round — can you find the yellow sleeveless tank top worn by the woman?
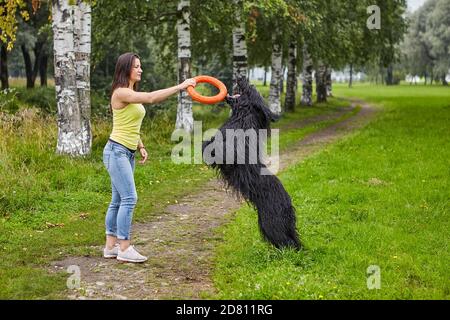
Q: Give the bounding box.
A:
[109,103,145,150]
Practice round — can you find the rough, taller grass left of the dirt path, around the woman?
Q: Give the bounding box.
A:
[0,81,352,299]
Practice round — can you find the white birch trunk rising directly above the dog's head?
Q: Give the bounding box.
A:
[233,0,247,87]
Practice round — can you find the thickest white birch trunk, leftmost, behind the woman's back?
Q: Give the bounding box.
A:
[52,0,91,156]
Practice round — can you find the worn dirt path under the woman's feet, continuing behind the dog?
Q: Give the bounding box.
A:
[51,100,375,299]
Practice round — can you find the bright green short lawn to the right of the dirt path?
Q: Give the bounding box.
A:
[214,85,450,299]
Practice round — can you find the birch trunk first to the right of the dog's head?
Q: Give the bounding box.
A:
[269,29,283,114]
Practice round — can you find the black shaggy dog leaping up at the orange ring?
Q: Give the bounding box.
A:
[203,78,301,249]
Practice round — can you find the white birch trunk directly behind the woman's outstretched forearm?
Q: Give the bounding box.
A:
[175,0,194,132]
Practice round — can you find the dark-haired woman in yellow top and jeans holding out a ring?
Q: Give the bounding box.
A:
[103,53,196,262]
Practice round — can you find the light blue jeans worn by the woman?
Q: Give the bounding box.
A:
[103,141,137,240]
